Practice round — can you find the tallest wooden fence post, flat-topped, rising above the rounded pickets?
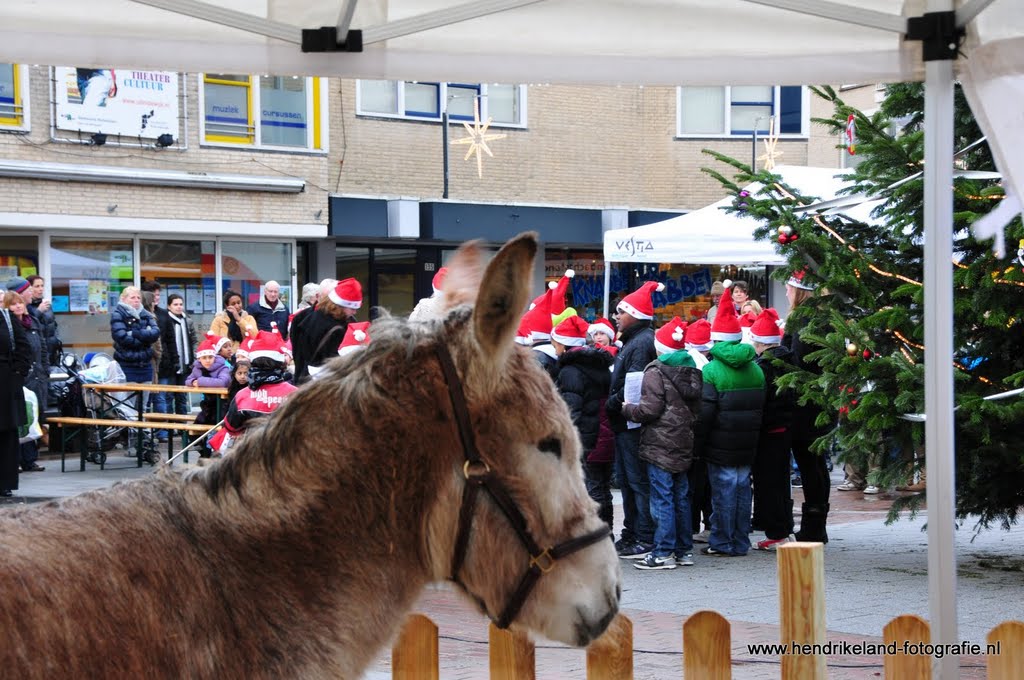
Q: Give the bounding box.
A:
[775,543,827,680]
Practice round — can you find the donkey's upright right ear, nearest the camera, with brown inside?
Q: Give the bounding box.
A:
[473,231,537,357]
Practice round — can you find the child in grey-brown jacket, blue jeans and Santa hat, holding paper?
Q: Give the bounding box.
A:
[623,316,701,569]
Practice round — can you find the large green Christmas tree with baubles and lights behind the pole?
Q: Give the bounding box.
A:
[705,84,1024,527]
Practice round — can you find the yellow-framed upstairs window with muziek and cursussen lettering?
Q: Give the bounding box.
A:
[201,74,327,151]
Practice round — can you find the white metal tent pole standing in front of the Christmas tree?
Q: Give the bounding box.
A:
[924,6,959,680]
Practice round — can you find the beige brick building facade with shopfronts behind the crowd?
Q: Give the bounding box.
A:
[0,65,874,350]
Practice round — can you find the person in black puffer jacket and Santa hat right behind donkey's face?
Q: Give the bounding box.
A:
[551,316,614,528]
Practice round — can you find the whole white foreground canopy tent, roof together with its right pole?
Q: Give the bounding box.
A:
[0,0,1024,678]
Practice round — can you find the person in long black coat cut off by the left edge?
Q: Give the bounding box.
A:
[0,301,32,497]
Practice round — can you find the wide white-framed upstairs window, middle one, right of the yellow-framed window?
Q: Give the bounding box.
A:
[355,80,526,127]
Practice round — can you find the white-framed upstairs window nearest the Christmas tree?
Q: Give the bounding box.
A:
[676,85,809,137]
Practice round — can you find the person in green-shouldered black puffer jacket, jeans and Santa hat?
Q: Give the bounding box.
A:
[698,288,765,556]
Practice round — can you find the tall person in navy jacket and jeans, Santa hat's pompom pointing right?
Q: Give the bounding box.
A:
[605,281,665,559]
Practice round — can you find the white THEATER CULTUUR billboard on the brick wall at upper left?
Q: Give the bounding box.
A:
[53,67,179,139]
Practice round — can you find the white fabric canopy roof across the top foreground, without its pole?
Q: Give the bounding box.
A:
[0,0,1024,85]
